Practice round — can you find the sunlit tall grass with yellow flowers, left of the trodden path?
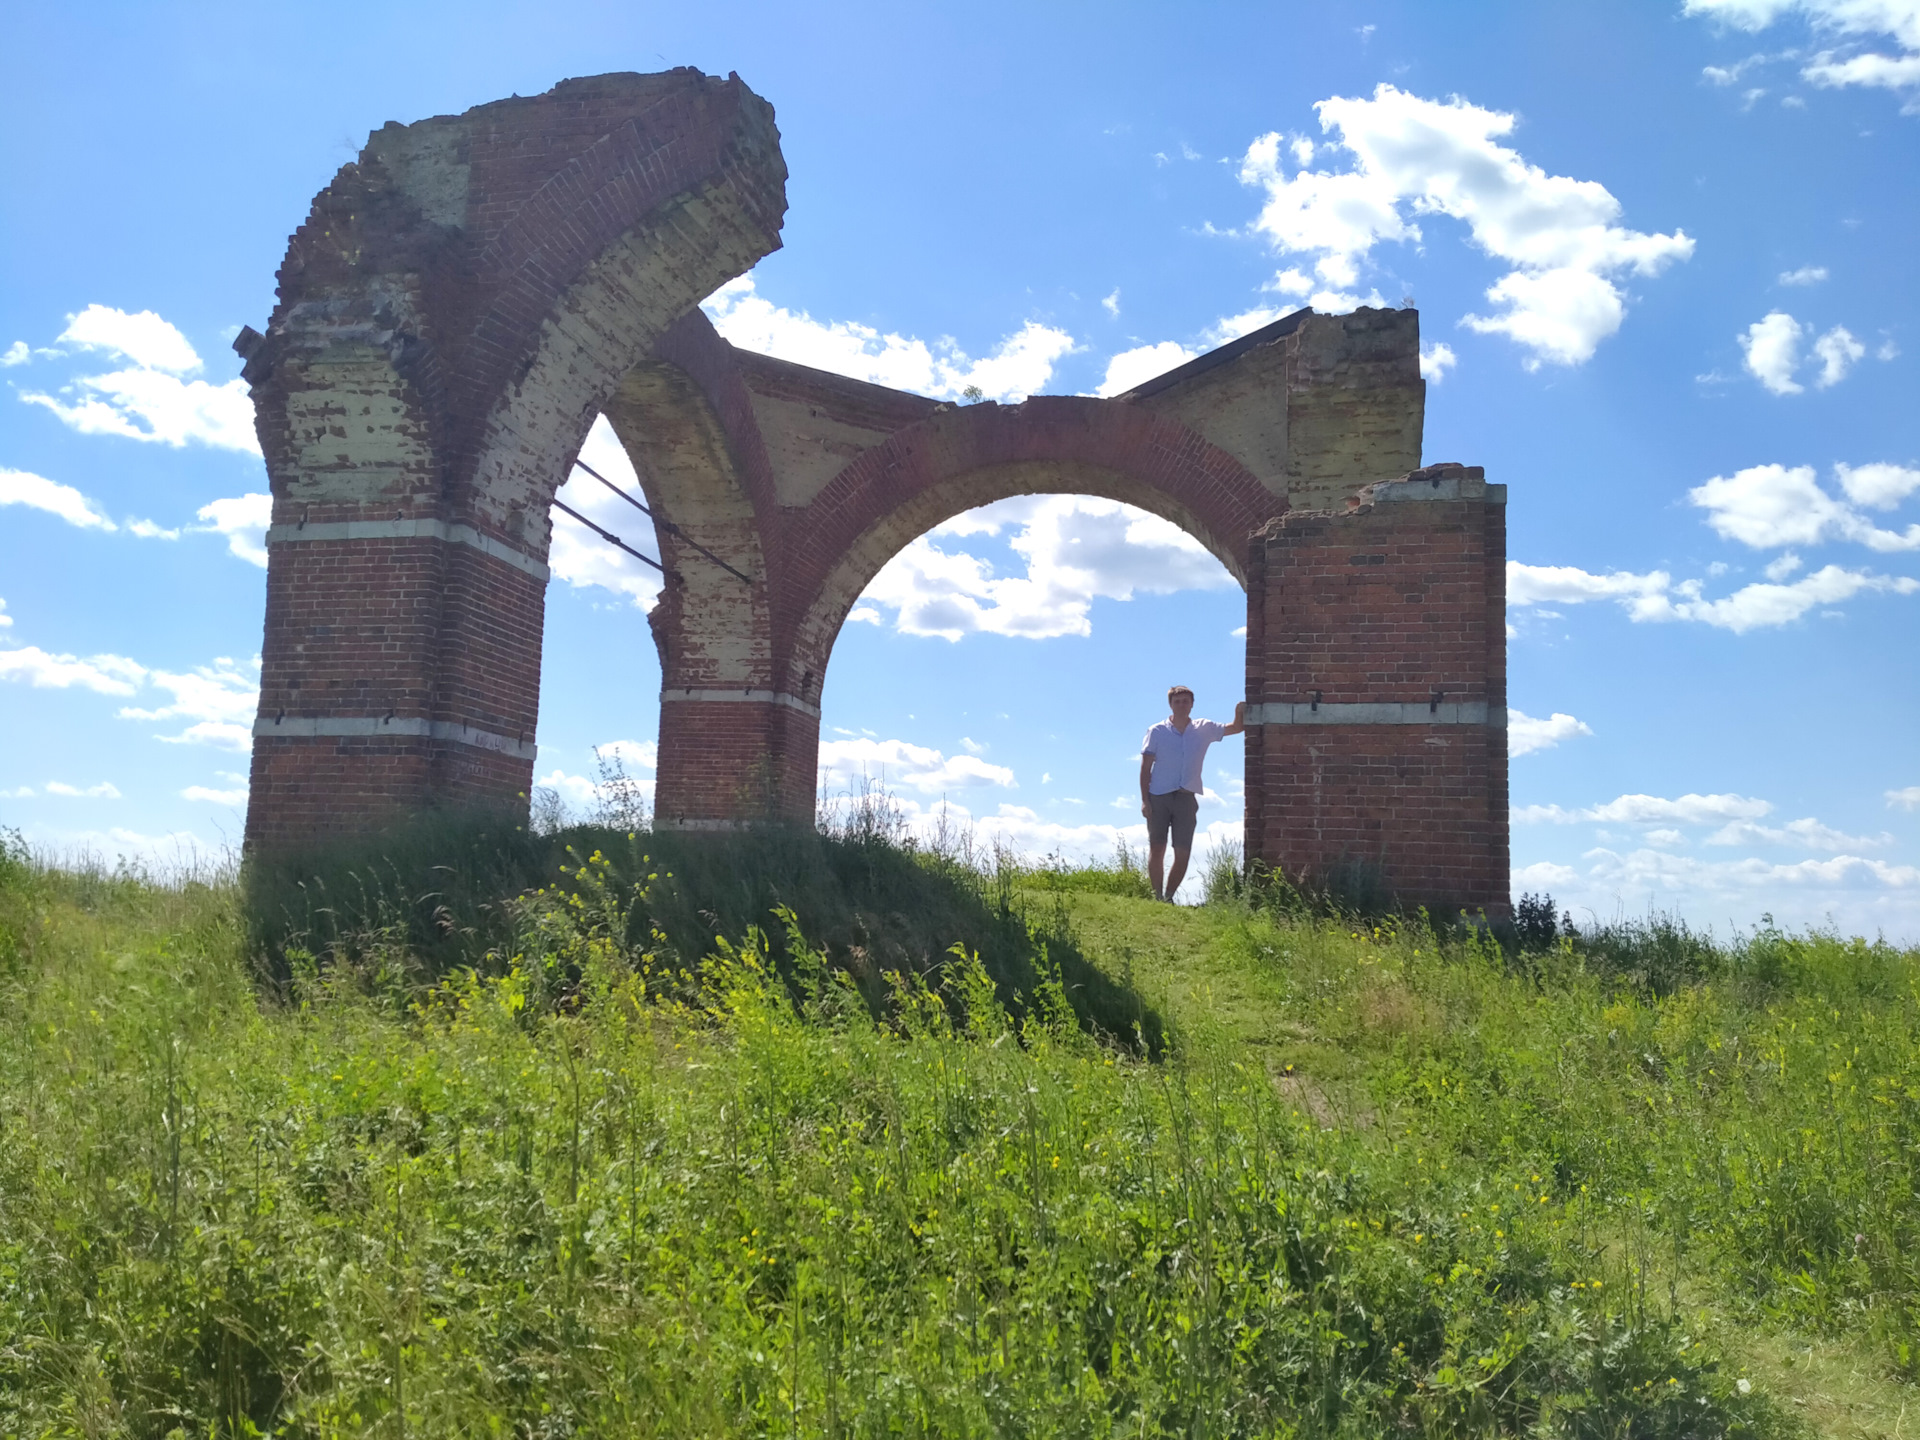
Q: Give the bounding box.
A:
[0,840,1768,1436]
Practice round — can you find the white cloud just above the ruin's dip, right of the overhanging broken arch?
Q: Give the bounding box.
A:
[703,275,1073,401]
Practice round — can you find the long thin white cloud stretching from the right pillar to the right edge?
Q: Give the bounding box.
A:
[1507,561,1920,634]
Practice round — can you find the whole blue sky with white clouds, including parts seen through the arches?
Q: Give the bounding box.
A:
[0,0,1920,939]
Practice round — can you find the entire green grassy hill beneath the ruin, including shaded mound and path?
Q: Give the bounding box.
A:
[0,831,1920,1436]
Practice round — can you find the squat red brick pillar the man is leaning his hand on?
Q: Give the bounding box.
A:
[1246,465,1511,918]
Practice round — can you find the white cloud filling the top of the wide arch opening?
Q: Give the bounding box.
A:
[849,495,1235,639]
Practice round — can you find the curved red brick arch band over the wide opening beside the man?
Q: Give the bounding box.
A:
[789,396,1286,718]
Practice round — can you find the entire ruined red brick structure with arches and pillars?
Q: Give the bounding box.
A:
[234,69,1509,914]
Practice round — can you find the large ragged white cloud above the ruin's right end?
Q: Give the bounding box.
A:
[1240,84,1693,365]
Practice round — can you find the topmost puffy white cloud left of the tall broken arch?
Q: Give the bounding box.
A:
[21,305,259,455]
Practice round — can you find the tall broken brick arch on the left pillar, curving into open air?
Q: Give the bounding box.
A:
[236,69,785,851]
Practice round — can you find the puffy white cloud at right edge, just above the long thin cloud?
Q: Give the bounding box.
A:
[1688,465,1920,553]
